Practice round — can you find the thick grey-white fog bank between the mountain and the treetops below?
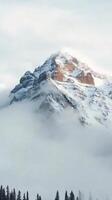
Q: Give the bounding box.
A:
[0,94,112,199]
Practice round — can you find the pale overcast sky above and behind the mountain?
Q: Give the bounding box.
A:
[0,0,112,87]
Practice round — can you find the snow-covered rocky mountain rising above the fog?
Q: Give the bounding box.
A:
[10,51,112,124]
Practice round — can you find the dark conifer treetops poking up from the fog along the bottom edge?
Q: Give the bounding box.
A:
[0,186,86,200]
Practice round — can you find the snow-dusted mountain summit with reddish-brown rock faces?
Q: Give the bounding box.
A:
[46,50,95,85]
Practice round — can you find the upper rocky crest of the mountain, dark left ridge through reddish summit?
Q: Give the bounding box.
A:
[11,53,99,101]
